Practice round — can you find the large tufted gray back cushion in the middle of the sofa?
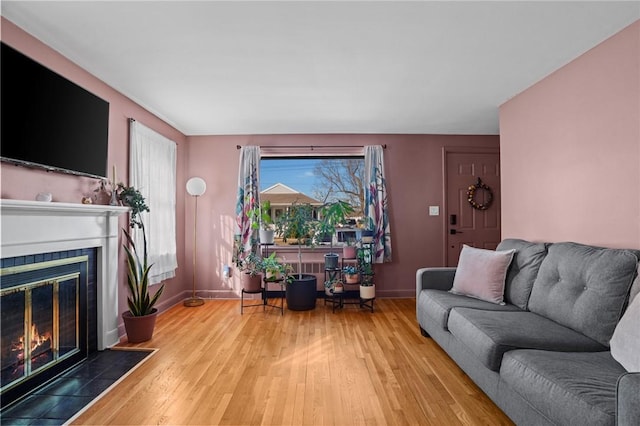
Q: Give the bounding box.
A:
[529,243,638,345]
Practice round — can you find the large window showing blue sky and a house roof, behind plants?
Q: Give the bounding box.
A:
[260,156,364,245]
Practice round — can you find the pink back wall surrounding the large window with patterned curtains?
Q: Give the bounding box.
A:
[185,135,499,297]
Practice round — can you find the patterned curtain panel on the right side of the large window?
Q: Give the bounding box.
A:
[364,145,391,263]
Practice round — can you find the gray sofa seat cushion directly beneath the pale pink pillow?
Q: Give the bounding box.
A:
[418,289,520,330]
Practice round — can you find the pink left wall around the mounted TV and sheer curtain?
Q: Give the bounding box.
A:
[0,18,187,326]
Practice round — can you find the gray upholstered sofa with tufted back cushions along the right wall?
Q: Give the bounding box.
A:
[416,239,640,426]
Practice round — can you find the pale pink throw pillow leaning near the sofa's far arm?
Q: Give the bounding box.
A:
[451,244,516,304]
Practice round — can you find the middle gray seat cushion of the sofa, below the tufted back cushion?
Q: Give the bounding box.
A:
[448,308,607,371]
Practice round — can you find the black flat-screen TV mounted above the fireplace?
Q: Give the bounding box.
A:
[0,43,109,177]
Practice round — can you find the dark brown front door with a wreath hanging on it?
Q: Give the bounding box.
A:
[445,152,500,266]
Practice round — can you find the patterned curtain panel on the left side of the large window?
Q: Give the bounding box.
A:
[233,146,260,267]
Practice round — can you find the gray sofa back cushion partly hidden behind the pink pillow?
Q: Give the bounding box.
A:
[496,238,547,309]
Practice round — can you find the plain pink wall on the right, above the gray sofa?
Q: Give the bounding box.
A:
[500,21,640,249]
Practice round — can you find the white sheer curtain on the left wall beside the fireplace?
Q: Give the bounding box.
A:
[129,120,178,284]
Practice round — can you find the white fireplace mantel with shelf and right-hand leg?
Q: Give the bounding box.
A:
[0,200,129,350]
